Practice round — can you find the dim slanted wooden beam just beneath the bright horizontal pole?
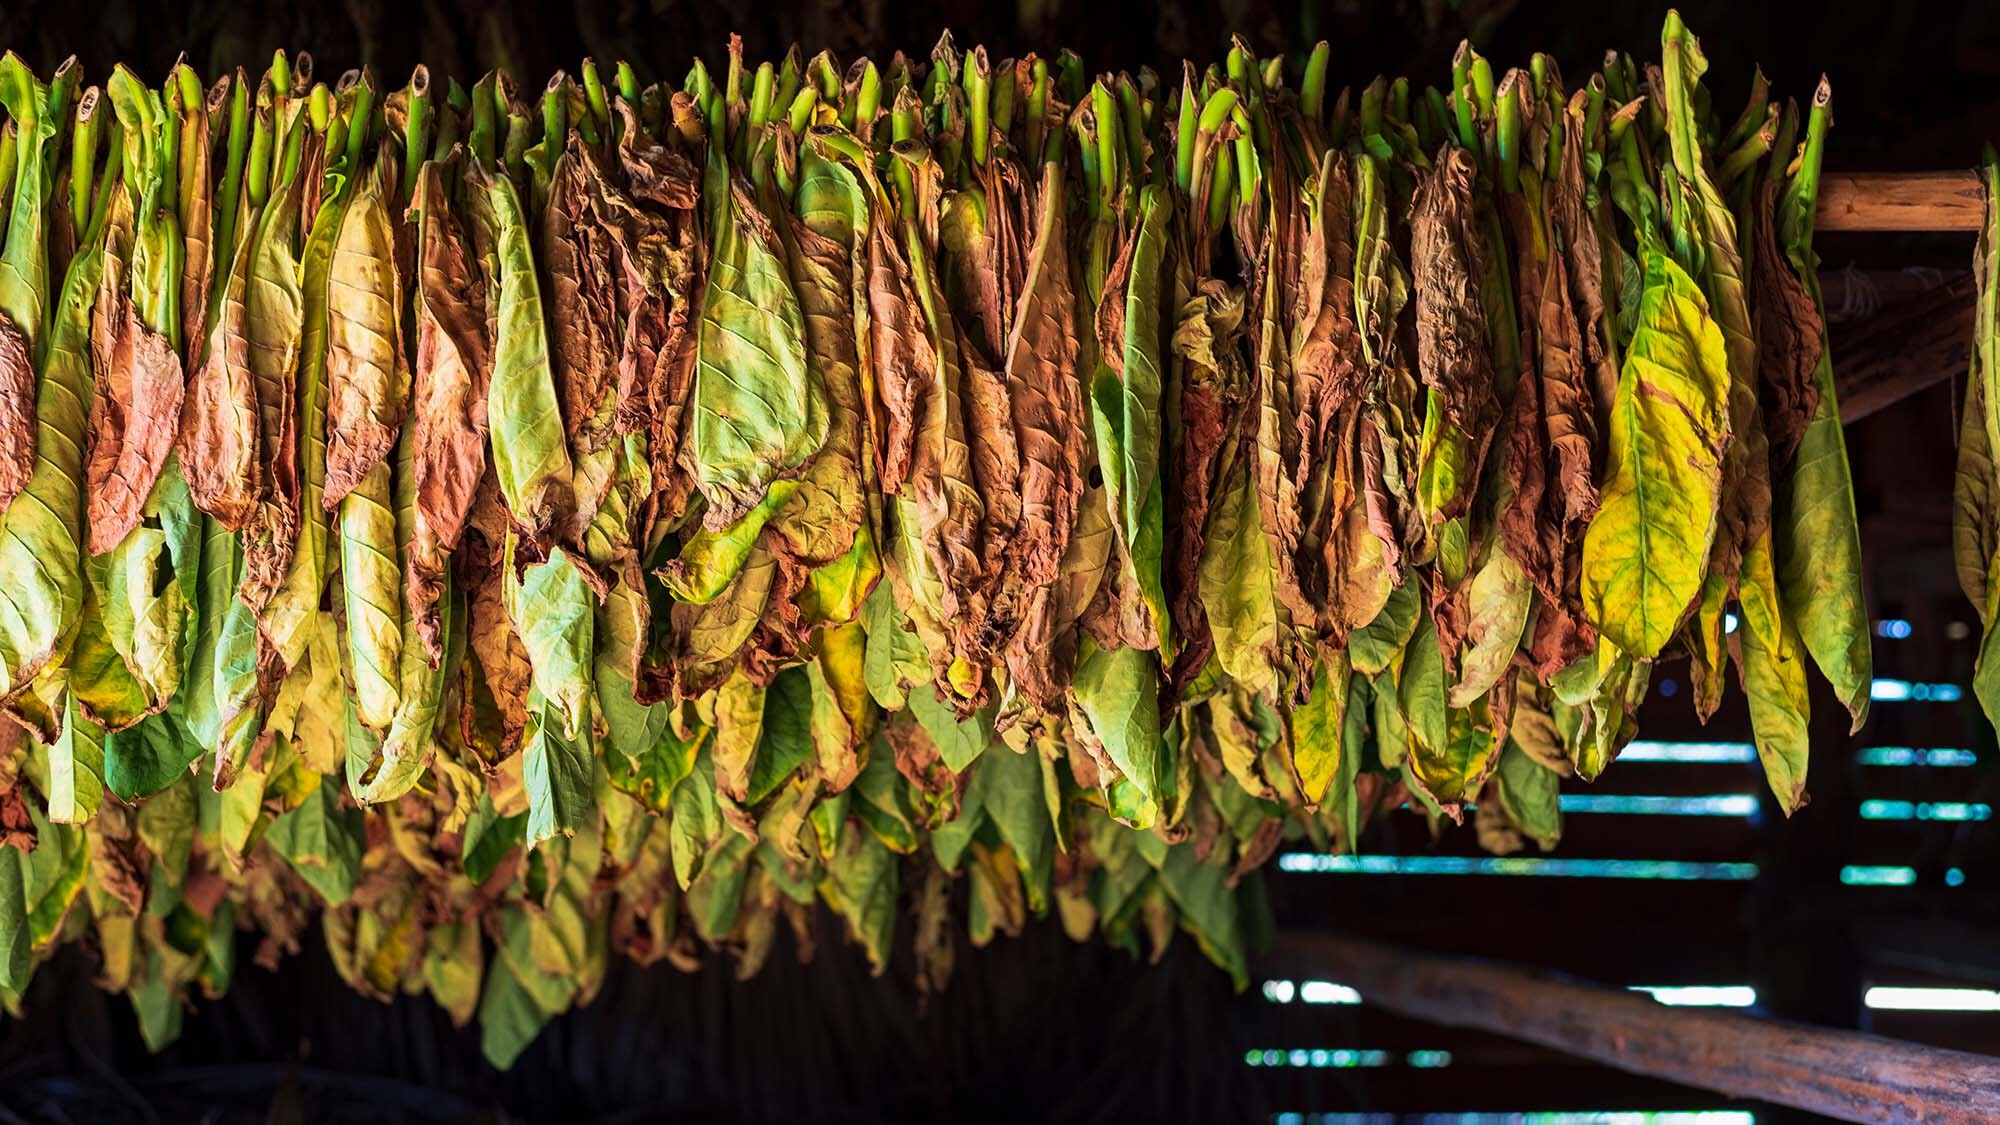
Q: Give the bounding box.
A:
[1828,270,1976,426]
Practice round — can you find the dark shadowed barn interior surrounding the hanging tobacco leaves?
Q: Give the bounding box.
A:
[0,0,2000,1125]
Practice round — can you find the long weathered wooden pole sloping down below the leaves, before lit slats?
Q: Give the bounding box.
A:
[1272,931,2000,1125]
